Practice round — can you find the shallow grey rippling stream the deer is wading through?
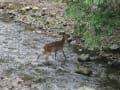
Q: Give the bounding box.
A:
[0,18,120,90]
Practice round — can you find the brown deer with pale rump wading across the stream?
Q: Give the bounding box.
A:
[37,33,70,60]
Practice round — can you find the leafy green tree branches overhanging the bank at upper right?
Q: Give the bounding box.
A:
[64,0,120,47]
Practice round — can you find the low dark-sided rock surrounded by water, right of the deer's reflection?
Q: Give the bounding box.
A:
[75,66,92,76]
